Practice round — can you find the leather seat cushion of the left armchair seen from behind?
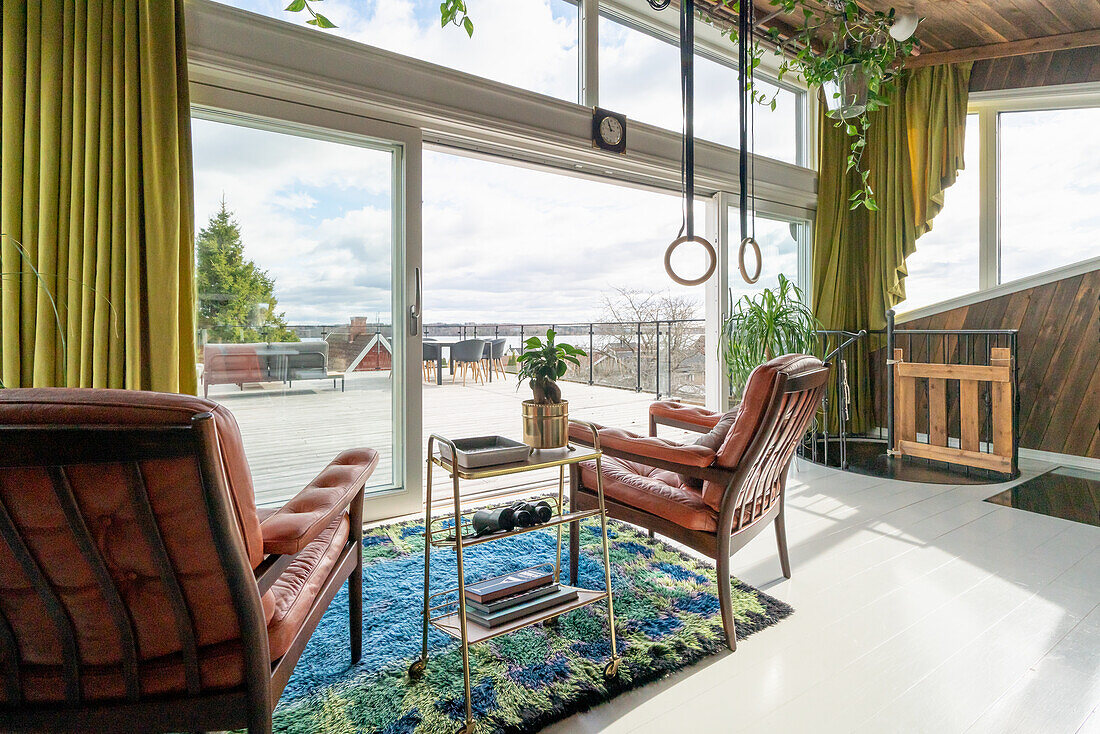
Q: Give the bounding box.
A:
[264,513,351,662]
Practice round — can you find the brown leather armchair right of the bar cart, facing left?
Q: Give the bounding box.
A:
[569,354,829,650]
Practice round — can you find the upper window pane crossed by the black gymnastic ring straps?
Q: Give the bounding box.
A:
[600,18,801,164]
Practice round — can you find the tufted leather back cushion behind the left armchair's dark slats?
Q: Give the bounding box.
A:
[0,388,268,701]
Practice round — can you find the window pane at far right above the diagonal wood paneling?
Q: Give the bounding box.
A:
[998,107,1100,283]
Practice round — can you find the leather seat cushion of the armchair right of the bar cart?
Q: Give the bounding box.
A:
[580,457,718,533]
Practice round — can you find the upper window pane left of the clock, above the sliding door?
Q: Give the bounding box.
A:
[209,0,580,102]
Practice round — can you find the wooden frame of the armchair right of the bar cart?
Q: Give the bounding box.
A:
[569,365,829,650]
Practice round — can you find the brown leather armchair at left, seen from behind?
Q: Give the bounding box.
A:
[0,390,378,732]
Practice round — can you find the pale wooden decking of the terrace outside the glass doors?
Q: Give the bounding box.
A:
[210,372,682,504]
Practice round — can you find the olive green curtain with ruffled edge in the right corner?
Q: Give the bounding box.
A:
[812,64,970,431]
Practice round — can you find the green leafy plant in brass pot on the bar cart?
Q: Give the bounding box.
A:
[516,329,587,449]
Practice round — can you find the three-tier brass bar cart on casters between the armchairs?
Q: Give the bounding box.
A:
[409,420,620,734]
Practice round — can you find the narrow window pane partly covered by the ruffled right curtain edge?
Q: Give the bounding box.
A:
[894,114,981,313]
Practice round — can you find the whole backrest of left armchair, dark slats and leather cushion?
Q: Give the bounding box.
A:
[0,390,271,717]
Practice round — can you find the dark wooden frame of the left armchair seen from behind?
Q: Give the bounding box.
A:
[0,413,365,734]
